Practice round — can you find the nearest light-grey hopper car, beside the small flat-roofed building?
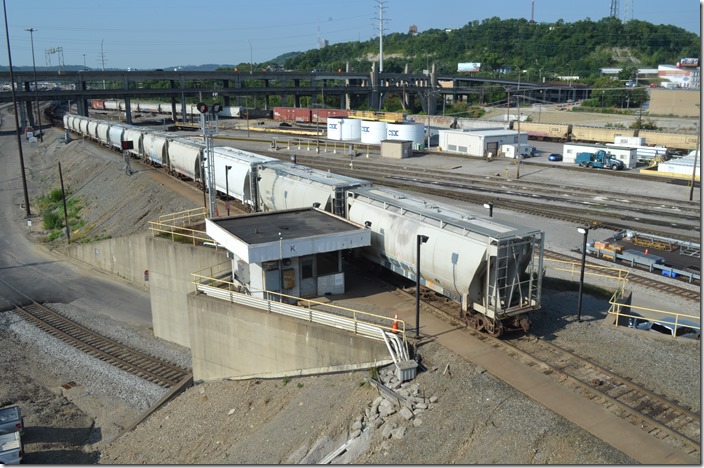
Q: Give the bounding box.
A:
[347,187,544,336]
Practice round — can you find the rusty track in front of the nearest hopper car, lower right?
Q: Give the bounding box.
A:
[397,287,701,457]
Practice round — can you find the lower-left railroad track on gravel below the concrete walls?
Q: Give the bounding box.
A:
[16,302,191,388]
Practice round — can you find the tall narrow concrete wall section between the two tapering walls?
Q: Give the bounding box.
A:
[145,237,227,348]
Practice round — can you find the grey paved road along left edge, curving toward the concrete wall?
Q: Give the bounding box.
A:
[0,110,151,327]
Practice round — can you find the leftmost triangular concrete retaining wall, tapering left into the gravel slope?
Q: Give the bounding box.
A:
[61,233,149,287]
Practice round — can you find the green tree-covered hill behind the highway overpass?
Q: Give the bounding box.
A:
[266,17,700,81]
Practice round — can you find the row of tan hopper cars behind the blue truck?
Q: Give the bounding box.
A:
[511,121,697,151]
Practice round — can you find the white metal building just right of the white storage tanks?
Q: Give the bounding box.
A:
[438,129,528,157]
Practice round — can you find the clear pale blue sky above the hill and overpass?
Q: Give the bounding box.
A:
[0,0,701,70]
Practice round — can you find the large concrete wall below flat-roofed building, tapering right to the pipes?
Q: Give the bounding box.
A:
[187,293,391,380]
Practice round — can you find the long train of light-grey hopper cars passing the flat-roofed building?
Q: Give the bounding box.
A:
[63,114,544,336]
